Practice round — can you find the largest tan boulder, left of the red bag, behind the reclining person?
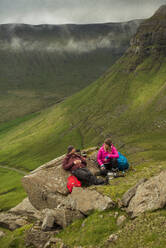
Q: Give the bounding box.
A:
[22,148,98,210]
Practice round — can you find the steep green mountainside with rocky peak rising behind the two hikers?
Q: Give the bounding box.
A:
[0,7,166,170]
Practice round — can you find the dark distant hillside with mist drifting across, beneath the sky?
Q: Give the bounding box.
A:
[0,20,141,122]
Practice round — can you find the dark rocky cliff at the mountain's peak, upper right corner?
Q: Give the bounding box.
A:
[127,5,166,70]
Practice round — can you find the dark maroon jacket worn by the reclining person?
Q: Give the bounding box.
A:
[63,153,87,171]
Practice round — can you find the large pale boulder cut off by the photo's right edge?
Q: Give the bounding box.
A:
[127,171,166,218]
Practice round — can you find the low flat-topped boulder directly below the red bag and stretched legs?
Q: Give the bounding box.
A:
[66,188,115,215]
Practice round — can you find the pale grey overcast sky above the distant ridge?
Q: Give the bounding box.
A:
[0,0,166,24]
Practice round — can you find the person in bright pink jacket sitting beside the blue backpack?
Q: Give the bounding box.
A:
[97,139,119,175]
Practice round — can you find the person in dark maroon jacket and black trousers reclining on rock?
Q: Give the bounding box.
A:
[63,146,108,186]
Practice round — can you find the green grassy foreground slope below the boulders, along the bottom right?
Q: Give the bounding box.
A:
[58,209,166,248]
